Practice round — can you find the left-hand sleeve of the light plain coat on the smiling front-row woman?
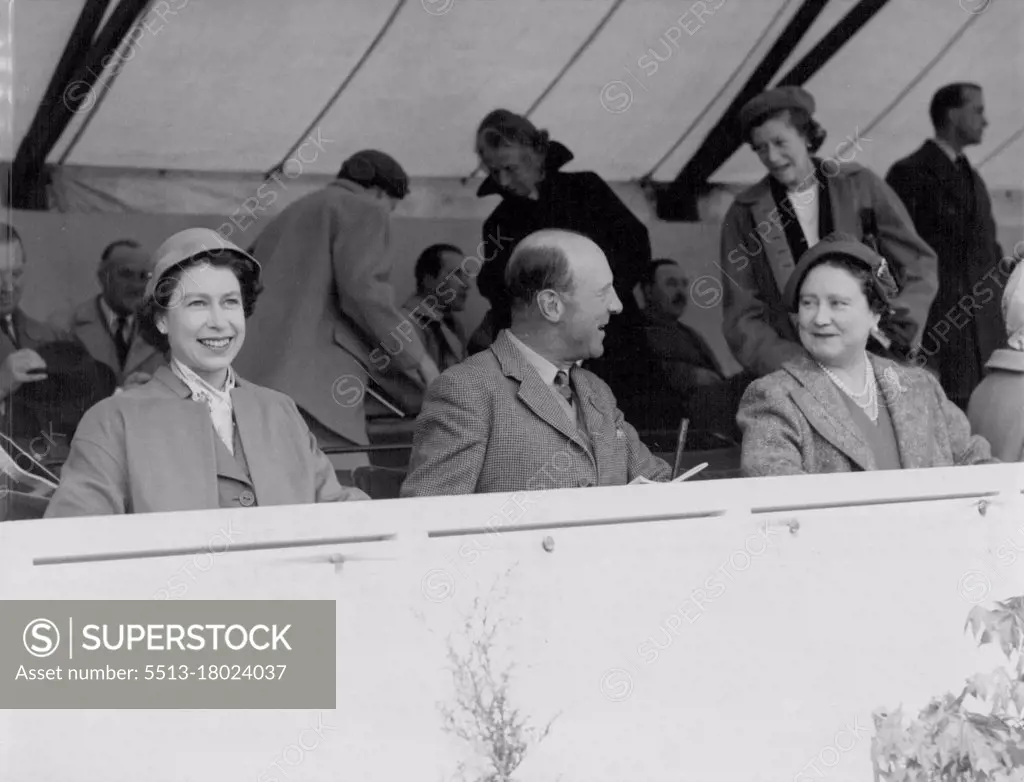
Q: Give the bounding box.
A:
[45,398,131,518]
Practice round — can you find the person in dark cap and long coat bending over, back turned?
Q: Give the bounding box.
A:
[236,149,438,470]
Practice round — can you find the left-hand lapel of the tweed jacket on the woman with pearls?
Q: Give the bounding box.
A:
[785,357,876,470]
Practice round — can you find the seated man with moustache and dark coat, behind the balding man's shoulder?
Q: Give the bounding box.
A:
[640,258,752,442]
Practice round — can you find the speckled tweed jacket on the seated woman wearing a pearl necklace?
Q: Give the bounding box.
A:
[736,355,997,477]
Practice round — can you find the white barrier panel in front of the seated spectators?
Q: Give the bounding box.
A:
[0,465,1024,782]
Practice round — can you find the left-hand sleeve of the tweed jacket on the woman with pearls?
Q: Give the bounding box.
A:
[736,376,809,478]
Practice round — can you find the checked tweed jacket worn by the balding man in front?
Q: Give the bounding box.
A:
[401,331,672,497]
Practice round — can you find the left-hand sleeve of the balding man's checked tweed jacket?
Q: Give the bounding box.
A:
[400,364,490,497]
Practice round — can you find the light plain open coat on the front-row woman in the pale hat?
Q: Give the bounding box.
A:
[46,366,368,517]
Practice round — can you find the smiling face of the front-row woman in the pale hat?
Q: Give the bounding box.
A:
[157,263,246,388]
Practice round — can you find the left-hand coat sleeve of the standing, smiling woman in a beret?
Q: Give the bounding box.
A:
[720,204,804,376]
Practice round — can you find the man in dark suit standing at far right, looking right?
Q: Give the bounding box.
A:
[886,83,1010,409]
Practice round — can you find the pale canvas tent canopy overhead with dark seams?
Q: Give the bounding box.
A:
[14,0,1024,196]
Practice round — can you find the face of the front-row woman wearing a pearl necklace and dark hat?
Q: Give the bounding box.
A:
[797,263,881,368]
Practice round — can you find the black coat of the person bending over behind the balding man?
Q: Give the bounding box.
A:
[476,141,651,328]
